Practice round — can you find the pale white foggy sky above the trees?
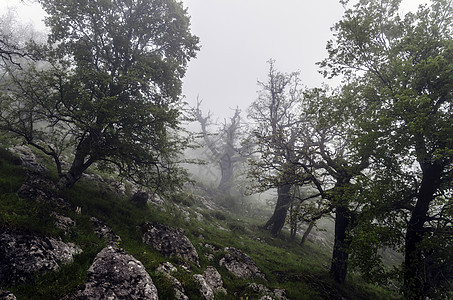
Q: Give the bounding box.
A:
[0,0,427,120]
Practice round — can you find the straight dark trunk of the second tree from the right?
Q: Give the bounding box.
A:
[330,205,352,284]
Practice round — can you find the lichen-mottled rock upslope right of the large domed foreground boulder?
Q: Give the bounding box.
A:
[143,222,200,266]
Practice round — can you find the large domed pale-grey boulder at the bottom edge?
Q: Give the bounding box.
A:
[64,246,159,300]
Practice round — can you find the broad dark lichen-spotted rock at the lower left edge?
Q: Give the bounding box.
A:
[0,232,82,285]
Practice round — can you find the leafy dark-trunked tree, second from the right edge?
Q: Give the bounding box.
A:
[299,88,374,283]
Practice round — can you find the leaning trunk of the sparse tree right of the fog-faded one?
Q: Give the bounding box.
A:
[264,184,291,236]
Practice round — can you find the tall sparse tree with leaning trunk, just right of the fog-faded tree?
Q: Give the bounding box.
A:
[248,60,304,235]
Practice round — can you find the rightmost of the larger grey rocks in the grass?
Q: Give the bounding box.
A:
[219,247,265,279]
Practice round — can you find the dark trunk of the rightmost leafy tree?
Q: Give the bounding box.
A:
[403,165,442,299]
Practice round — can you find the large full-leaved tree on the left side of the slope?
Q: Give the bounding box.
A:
[0,0,198,192]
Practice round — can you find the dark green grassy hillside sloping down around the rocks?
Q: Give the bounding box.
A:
[0,149,398,299]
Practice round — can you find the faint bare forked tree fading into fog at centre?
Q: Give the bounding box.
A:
[193,101,246,198]
